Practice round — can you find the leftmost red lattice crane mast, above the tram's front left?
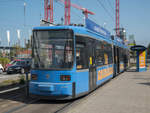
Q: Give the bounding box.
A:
[44,0,53,23]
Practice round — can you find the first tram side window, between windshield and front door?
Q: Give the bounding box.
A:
[76,37,88,70]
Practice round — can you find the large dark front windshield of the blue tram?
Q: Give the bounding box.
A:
[32,30,73,69]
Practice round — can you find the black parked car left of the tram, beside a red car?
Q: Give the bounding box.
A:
[6,59,31,74]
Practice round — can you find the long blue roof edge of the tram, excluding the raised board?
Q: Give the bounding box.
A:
[33,26,128,49]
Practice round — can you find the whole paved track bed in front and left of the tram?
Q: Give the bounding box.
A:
[0,83,95,113]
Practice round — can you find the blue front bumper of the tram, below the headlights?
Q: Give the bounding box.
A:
[29,82,73,96]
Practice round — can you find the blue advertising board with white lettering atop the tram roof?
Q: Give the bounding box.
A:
[85,18,110,36]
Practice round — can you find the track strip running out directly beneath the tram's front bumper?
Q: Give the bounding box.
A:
[2,96,75,113]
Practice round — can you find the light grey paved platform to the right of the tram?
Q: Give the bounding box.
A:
[64,68,150,113]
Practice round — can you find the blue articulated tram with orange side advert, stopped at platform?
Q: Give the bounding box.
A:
[29,19,128,100]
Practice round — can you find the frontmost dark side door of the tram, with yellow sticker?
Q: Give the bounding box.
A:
[89,41,97,91]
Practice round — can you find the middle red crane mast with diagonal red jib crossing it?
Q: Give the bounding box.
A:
[56,0,94,25]
